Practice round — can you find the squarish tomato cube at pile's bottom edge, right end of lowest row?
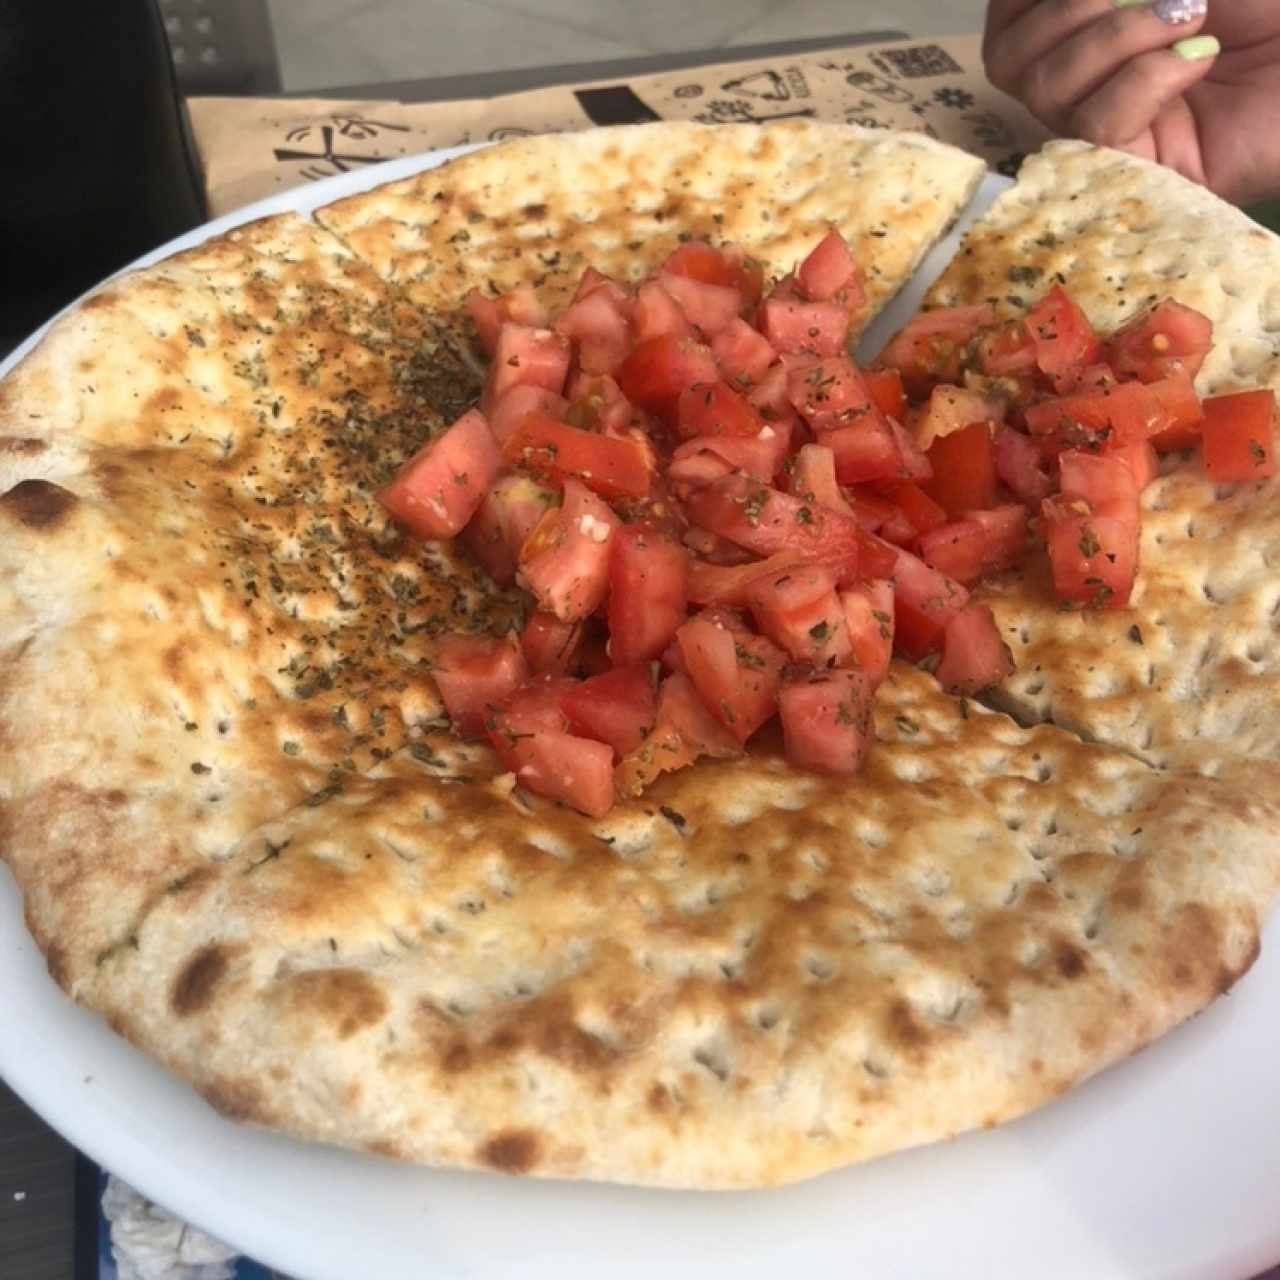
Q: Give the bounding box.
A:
[778,668,874,776]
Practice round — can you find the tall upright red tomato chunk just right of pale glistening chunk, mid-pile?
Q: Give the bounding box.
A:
[608,524,689,667]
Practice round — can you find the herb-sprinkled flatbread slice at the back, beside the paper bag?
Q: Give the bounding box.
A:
[316,120,983,337]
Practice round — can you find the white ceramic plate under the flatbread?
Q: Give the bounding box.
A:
[0,148,1280,1280]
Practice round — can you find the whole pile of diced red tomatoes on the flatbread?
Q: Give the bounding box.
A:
[380,232,1275,817]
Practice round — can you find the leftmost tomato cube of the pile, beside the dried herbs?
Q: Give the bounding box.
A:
[378,410,502,539]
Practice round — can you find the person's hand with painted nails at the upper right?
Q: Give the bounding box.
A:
[983,0,1280,204]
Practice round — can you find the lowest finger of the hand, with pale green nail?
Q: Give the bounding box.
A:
[1066,36,1219,147]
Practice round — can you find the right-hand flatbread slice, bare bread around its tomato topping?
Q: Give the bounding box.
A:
[925,142,1280,790]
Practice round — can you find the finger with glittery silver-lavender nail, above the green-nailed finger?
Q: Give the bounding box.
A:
[1016,6,1204,136]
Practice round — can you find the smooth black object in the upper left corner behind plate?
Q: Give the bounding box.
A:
[0,0,206,343]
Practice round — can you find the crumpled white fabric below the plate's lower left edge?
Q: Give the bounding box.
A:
[102,1174,237,1280]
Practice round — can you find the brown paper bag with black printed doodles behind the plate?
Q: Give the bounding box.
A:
[188,35,1047,214]
